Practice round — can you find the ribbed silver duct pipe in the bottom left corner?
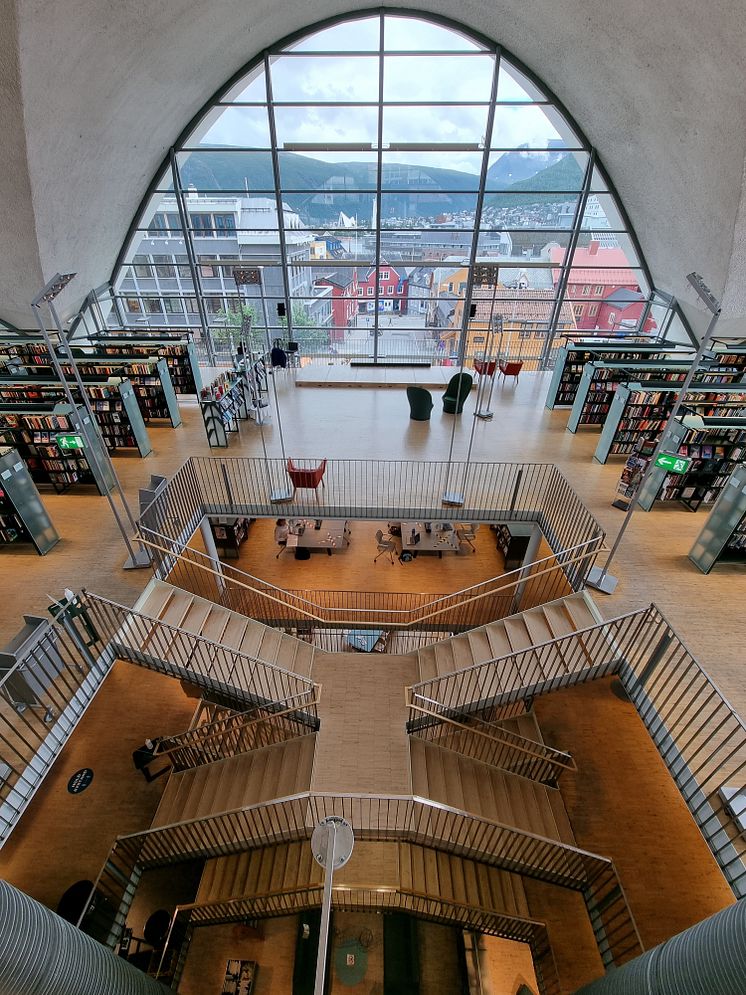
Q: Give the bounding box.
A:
[0,881,170,995]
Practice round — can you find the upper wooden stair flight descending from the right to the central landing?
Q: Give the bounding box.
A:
[417,591,603,683]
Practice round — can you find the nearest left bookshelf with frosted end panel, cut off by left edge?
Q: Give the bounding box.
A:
[0,443,60,556]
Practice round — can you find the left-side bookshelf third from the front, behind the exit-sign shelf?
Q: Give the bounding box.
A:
[0,377,153,456]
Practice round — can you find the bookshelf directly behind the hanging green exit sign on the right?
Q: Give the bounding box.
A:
[639,409,746,511]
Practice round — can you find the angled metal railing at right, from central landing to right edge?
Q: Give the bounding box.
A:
[408,605,746,898]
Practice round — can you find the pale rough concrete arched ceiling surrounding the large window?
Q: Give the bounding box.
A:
[0,0,746,327]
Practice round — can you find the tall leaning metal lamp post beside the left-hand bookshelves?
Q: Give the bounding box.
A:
[31,273,151,570]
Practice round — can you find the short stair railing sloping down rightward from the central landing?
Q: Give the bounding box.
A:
[407,689,577,786]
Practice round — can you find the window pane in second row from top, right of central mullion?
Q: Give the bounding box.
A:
[383,55,495,104]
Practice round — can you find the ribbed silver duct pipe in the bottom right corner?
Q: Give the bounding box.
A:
[576,898,746,995]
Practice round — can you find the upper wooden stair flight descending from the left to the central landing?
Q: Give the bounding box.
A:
[135,580,314,677]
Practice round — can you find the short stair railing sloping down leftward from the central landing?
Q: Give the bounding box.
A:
[156,690,320,772]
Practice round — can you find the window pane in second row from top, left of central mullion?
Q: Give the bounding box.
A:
[270,55,379,104]
